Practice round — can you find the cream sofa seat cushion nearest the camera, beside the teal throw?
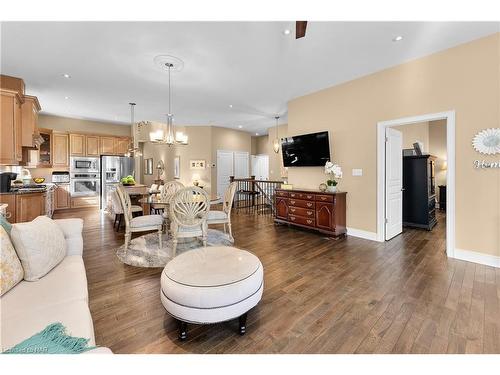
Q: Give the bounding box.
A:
[0,297,95,351]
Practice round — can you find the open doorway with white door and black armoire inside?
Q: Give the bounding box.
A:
[377,111,455,257]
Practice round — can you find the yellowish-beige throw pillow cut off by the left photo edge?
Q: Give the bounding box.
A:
[0,226,24,296]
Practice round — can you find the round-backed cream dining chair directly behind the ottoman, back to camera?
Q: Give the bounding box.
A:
[169,186,210,257]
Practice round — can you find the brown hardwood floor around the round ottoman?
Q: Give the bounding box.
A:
[55,210,500,353]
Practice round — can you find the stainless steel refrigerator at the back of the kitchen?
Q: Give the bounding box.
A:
[101,156,135,208]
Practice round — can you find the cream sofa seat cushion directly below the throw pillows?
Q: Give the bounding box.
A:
[2,255,88,318]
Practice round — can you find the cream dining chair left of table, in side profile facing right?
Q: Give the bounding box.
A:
[116,186,163,251]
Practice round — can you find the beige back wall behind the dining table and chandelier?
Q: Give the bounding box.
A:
[143,126,255,196]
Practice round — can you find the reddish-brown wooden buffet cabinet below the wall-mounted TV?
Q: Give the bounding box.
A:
[274,189,347,237]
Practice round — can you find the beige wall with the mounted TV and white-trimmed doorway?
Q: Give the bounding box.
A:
[288,33,500,256]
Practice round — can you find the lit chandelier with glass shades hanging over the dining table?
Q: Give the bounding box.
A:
[149,56,188,146]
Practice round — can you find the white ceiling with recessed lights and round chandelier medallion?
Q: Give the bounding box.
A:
[1,22,500,133]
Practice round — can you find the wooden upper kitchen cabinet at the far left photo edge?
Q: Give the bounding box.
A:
[0,89,23,165]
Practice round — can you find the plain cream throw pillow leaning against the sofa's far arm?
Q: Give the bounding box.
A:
[10,216,66,281]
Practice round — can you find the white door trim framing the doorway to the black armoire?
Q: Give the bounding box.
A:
[377,110,455,258]
